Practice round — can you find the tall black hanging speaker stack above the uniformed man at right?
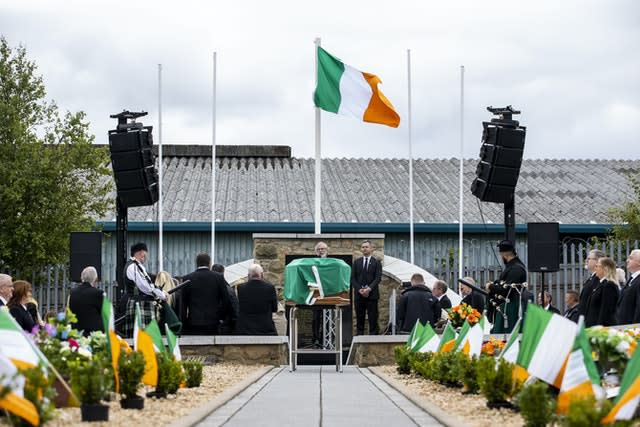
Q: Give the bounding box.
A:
[471,122,526,203]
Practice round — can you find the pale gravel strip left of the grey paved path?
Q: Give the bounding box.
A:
[46,363,263,427]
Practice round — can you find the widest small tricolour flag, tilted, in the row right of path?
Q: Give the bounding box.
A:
[516,304,577,388]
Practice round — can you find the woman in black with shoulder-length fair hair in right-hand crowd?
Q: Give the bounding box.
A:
[584,257,618,327]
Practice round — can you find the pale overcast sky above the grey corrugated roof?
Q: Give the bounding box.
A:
[0,0,640,159]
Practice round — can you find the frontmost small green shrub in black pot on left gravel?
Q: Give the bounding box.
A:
[71,358,109,421]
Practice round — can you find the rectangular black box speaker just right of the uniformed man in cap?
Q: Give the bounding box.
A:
[527,222,560,272]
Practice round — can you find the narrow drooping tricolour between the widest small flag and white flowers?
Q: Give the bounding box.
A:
[557,317,604,414]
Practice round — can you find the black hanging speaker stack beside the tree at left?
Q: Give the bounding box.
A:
[109,126,158,207]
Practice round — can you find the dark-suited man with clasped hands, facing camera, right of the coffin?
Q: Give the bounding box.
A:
[351,240,382,335]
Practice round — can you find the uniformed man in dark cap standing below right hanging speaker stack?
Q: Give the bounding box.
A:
[485,240,527,334]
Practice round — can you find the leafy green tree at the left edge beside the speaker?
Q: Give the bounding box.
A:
[0,37,113,277]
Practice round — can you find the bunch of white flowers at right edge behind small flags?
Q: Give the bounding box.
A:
[586,326,638,375]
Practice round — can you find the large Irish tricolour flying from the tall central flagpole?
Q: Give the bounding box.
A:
[313,46,400,128]
